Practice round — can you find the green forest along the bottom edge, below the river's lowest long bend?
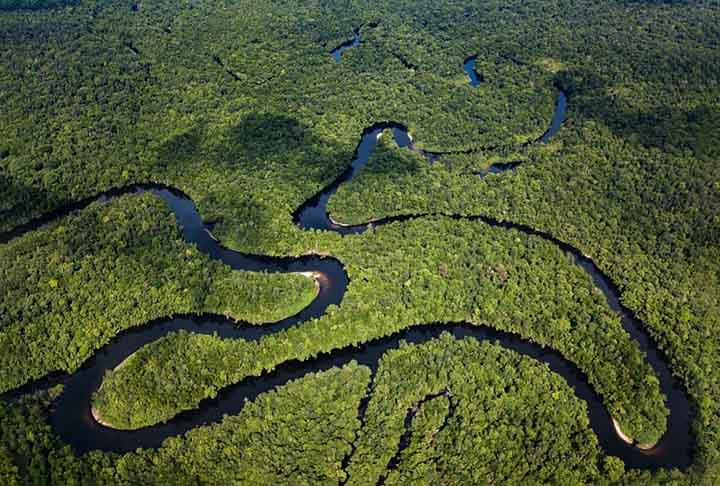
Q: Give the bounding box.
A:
[5,336,669,485]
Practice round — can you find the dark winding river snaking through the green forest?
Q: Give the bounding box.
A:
[0,58,692,469]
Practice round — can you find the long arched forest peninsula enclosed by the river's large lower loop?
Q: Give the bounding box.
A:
[96,218,666,442]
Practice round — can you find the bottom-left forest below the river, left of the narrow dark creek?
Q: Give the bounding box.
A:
[0,364,369,486]
